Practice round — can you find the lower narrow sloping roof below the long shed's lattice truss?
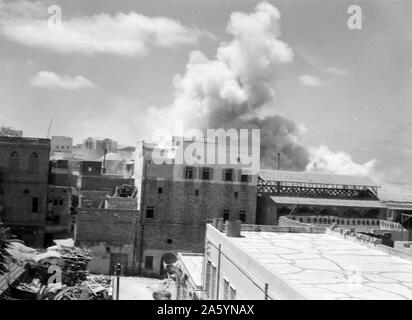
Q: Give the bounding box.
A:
[270,196,386,208]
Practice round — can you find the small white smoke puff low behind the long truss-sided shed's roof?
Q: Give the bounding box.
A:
[306,145,377,178]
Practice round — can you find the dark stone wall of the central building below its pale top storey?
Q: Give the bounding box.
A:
[142,179,256,275]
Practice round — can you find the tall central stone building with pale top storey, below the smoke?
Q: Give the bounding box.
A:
[135,138,257,275]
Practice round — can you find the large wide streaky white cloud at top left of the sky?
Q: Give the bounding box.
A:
[0,1,203,56]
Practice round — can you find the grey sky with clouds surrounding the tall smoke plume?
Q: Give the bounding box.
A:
[0,0,412,184]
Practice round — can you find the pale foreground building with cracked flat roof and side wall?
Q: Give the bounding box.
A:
[188,222,412,300]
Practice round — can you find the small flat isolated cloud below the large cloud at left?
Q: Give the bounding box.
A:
[30,71,96,90]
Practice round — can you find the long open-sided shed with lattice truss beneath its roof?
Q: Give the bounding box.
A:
[256,170,387,230]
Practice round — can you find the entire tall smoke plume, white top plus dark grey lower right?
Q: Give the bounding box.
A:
[168,2,309,170]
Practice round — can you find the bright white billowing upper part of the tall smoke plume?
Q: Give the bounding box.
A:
[169,2,293,127]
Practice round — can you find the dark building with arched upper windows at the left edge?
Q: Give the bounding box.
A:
[0,137,50,247]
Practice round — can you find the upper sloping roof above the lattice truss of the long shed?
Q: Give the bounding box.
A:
[259,170,379,186]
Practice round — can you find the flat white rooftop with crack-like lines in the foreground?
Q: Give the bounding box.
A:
[212,227,412,300]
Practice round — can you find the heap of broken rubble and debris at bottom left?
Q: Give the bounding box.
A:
[3,239,111,300]
